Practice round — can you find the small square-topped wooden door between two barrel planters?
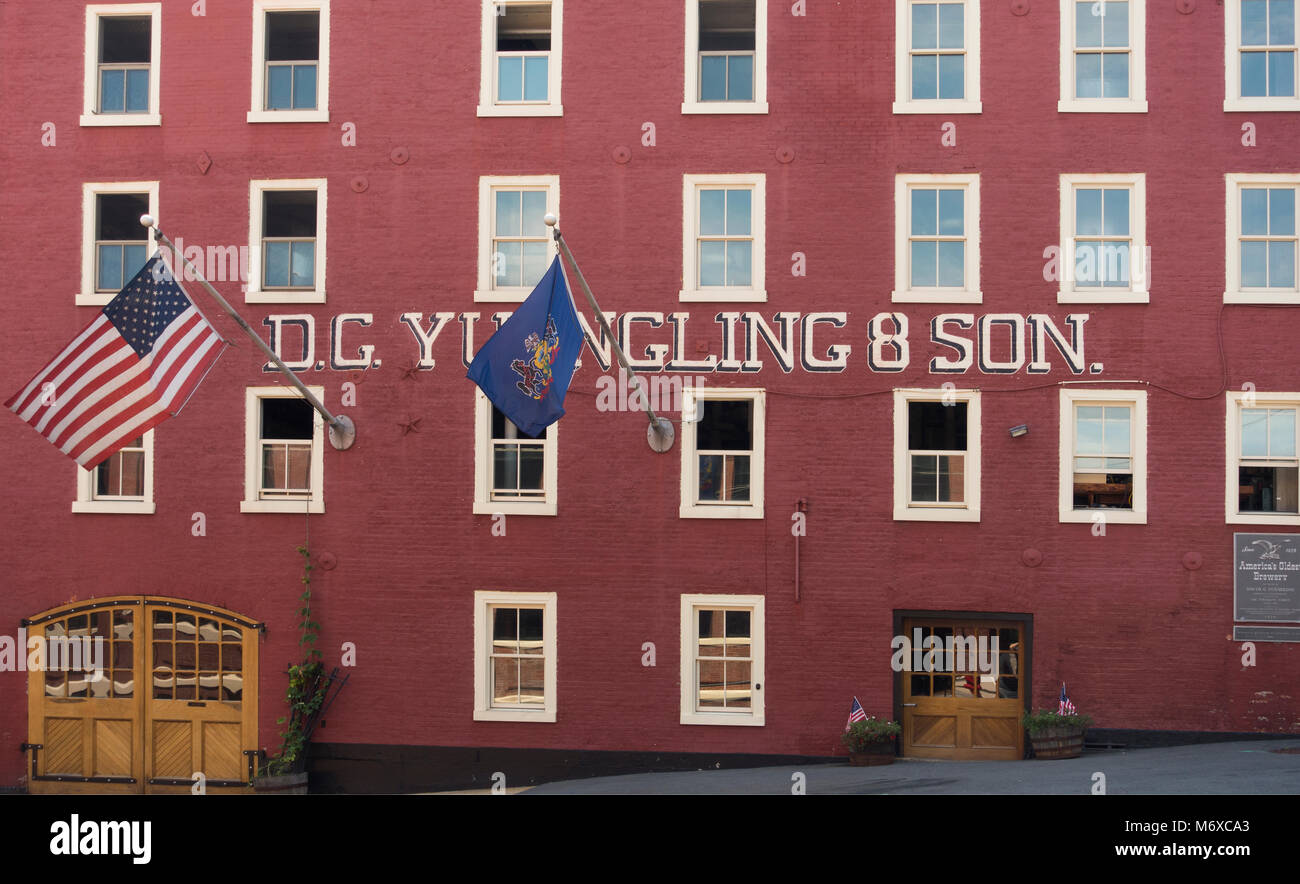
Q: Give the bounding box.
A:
[900,618,1028,761]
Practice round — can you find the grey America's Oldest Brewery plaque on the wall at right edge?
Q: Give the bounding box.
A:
[1232,534,1300,623]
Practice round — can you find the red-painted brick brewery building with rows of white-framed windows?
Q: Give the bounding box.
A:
[0,0,1300,790]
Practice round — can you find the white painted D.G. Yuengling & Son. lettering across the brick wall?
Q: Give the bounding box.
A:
[261,311,1102,374]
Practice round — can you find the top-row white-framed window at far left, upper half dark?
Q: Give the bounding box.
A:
[81,3,163,126]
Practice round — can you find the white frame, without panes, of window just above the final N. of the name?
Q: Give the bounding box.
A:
[1057,173,1151,304]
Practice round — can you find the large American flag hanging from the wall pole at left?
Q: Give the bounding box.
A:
[5,254,226,469]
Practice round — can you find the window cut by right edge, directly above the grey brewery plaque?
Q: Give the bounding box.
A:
[1225,393,1300,525]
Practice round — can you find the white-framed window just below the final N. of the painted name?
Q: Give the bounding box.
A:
[1061,389,1147,525]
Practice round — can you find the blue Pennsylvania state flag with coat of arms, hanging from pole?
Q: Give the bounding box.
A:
[465,256,582,436]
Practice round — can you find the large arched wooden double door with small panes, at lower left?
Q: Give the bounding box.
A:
[22,595,260,793]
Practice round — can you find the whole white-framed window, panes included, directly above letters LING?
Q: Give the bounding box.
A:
[679,174,767,302]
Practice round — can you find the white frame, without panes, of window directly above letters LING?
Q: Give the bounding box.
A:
[677,173,767,303]
